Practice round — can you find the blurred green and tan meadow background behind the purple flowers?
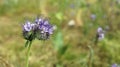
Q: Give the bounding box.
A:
[0,0,120,67]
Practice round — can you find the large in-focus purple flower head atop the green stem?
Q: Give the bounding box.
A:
[23,17,54,40]
